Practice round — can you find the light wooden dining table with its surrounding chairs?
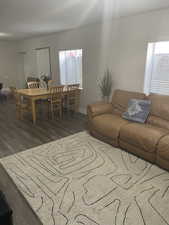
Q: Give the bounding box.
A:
[13,80,81,124]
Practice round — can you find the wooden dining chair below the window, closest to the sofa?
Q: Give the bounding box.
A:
[66,84,80,112]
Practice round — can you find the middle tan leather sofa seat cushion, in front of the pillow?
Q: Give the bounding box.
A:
[120,123,168,153]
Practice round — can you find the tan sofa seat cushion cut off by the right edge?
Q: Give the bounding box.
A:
[157,135,169,163]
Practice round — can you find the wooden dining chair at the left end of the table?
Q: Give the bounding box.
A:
[14,90,31,119]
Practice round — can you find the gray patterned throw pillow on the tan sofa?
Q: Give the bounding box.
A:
[122,99,151,123]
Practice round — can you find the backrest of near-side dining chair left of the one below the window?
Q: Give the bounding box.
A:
[49,85,64,102]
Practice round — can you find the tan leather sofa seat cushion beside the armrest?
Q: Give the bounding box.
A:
[92,114,130,142]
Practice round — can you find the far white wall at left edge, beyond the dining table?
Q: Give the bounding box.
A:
[0,41,23,87]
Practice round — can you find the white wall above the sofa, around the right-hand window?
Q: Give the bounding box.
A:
[110,9,169,91]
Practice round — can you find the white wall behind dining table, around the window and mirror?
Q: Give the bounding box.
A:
[21,24,117,112]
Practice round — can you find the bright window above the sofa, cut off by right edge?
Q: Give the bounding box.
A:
[144,41,169,95]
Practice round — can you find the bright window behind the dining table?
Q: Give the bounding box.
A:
[59,49,82,87]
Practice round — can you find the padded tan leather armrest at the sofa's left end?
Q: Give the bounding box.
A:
[87,102,112,119]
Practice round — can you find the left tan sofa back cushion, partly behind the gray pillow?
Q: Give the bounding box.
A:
[112,90,145,115]
